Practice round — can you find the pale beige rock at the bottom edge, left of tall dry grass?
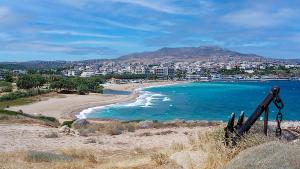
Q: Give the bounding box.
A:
[170,151,207,169]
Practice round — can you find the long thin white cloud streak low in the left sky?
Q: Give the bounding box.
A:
[40,30,121,38]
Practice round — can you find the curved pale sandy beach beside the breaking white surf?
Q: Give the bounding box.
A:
[9,81,180,121]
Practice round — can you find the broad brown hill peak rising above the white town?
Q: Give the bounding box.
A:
[119,46,263,60]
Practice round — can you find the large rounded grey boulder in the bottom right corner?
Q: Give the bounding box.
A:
[225,141,300,169]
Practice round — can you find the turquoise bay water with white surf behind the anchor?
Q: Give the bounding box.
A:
[83,81,300,121]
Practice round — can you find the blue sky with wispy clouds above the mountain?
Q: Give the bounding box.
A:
[0,0,300,61]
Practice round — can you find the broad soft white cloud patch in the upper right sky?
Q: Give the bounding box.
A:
[222,8,294,28]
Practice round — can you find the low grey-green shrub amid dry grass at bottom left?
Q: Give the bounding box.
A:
[25,151,73,162]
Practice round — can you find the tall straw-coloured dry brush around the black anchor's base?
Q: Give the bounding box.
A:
[190,126,276,169]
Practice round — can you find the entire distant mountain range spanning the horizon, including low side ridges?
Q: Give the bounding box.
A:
[0,46,300,69]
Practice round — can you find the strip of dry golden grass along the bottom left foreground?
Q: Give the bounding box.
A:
[0,147,179,169]
